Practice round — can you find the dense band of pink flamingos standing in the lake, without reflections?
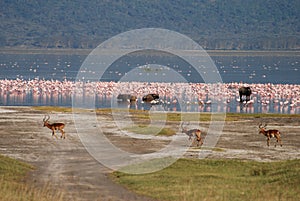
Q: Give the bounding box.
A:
[0,79,300,113]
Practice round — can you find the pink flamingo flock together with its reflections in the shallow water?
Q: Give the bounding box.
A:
[0,80,300,114]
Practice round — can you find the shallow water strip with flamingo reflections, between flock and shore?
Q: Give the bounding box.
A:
[0,90,300,114]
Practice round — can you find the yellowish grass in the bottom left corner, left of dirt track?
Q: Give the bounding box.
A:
[0,155,63,201]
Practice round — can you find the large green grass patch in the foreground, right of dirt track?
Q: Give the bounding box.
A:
[111,159,300,201]
